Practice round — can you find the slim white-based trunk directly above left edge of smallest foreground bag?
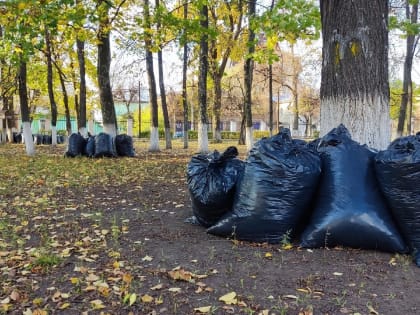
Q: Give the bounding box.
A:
[198,5,209,153]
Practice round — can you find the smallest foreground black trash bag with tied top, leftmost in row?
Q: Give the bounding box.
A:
[187,147,244,227]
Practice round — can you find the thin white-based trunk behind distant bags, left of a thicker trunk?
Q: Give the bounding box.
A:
[76,39,87,137]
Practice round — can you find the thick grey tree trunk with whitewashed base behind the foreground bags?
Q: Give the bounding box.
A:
[320,0,391,149]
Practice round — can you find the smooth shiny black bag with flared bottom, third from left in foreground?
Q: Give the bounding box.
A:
[301,125,406,252]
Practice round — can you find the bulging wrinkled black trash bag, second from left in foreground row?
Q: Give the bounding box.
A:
[207,128,321,243]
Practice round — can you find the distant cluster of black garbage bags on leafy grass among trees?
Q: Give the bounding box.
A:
[65,132,135,158]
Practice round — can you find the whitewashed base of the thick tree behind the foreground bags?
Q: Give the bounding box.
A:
[320,95,391,150]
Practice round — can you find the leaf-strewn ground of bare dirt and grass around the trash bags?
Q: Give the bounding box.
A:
[0,140,420,315]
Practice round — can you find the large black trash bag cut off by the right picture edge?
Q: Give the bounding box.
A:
[375,135,420,267]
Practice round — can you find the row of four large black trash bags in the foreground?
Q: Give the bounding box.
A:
[187,125,420,266]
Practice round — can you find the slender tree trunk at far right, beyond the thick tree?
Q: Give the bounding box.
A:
[397,1,418,137]
